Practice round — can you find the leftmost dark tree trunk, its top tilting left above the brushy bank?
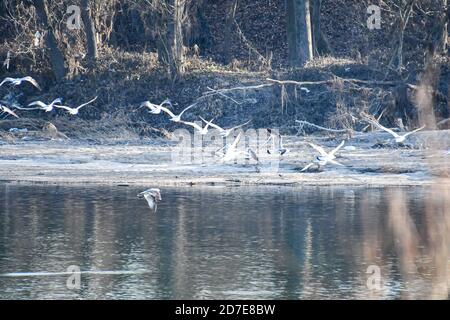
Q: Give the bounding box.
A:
[33,0,67,80]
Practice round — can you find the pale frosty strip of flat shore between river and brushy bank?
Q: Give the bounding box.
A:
[0,131,450,186]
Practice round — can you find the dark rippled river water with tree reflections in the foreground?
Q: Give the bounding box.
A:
[0,185,450,299]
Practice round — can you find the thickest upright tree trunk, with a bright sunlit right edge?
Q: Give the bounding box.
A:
[286,0,313,67]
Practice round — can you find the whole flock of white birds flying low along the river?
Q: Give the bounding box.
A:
[0,76,425,212]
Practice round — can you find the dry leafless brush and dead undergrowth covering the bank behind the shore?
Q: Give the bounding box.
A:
[0,0,450,137]
